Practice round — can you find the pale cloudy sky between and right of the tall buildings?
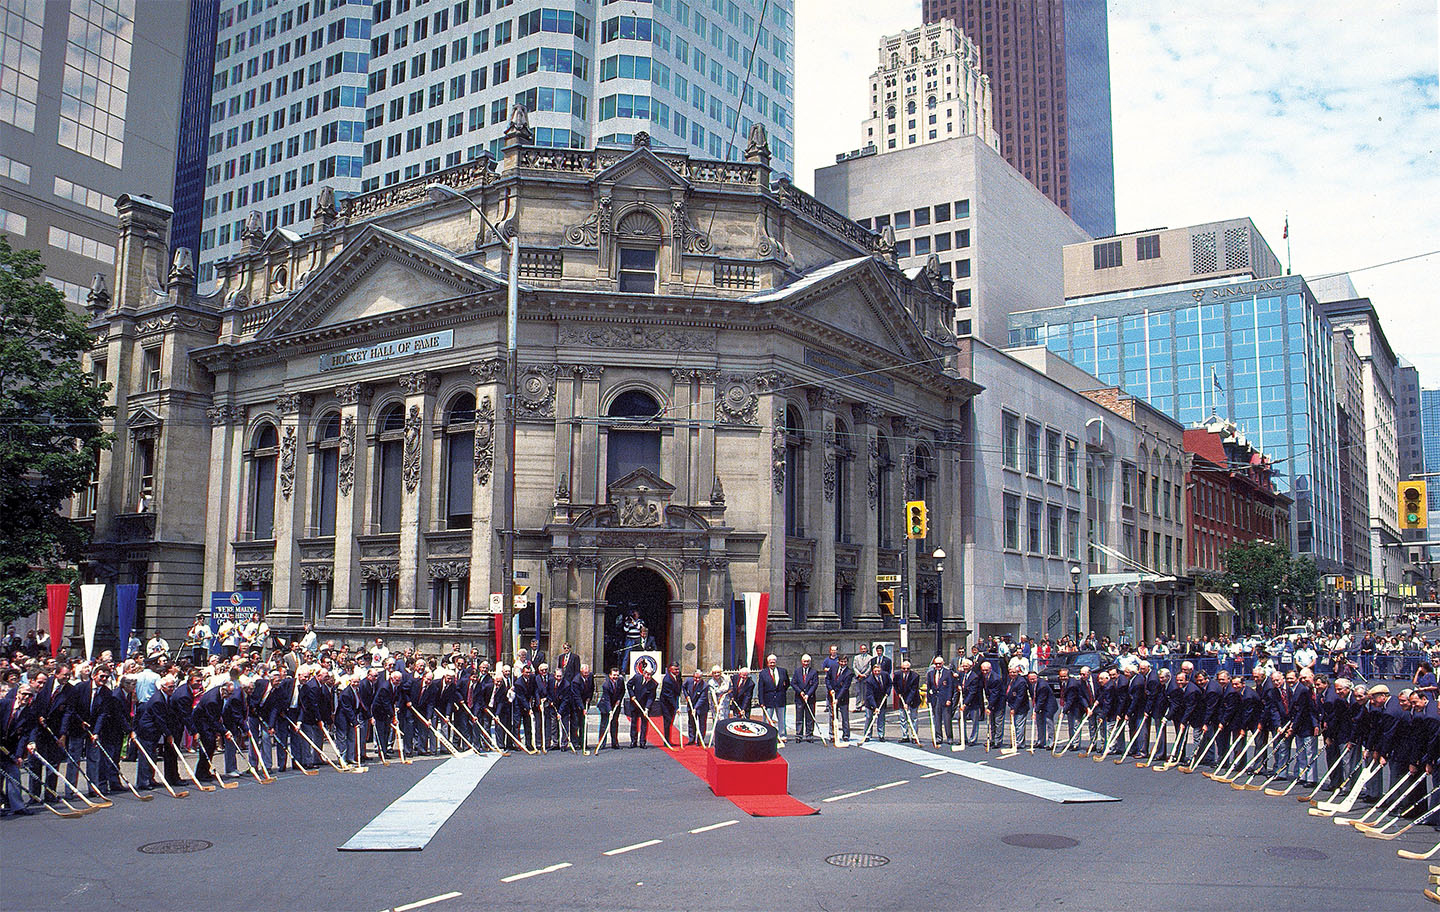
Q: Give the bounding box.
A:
[795,0,1440,377]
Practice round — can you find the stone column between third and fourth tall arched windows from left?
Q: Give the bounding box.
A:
[390,370,438,627]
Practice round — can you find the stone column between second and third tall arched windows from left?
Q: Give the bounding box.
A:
[325,383,372,627]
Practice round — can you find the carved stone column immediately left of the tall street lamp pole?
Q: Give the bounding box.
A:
[469,357,505,622]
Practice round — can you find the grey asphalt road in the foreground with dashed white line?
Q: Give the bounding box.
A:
[0,726,1440,912]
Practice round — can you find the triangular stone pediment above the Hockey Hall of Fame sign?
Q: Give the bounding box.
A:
[256,225,504,339]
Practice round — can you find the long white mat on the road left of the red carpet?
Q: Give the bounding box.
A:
[340,754,500,851]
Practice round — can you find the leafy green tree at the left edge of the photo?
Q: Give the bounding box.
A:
[0,235,114,622]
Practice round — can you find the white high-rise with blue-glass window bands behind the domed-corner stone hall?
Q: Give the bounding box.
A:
[199,0,795,284]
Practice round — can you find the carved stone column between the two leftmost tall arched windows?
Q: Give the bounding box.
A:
[271,393,310,627]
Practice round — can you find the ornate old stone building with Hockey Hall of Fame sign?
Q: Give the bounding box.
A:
[76,112,979,671]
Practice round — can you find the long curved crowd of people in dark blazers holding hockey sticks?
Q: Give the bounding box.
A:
[0,628,1440,815]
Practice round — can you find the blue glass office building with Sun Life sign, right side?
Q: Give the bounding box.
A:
[1009,275,1339,568]
